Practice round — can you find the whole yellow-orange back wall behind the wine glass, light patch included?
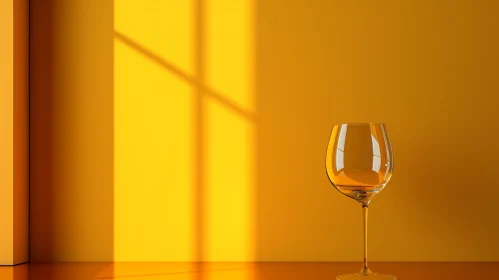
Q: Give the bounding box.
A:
[31,0,499,261]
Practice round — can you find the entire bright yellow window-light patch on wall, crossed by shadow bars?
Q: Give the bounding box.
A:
[114,0,255,261]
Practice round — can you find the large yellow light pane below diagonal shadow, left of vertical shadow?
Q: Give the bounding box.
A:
[114,38,194,261]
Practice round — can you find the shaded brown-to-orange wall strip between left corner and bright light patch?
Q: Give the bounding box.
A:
[30,0,113,261]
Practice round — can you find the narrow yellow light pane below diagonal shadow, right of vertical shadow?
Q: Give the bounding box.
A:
[205,102,254,261]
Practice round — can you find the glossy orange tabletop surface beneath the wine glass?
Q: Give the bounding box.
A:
[0,262,499,280]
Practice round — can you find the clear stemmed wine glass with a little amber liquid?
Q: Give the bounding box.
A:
[326,123,397,280]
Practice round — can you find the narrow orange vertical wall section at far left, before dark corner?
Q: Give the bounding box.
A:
[0,0,28,265]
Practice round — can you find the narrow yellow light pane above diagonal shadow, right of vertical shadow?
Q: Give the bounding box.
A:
[204,0,254,111]
